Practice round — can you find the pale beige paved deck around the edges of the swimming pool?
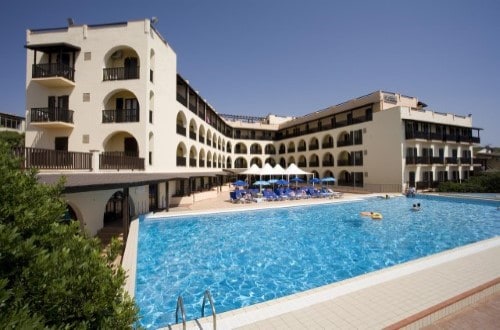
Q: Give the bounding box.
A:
[123,192,500,329]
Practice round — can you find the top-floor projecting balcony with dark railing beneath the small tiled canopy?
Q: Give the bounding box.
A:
[31,63,75,87]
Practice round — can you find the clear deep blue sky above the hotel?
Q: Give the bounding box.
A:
[0,0,500,146]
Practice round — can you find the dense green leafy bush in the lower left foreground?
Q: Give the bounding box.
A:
[0,143,138,329]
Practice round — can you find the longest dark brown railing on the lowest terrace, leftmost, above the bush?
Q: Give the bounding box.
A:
[13,147,92,171]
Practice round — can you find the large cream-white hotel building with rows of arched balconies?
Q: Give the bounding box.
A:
[24,19,480,234]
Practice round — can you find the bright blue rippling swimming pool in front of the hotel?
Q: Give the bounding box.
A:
[135,197,500,328]
